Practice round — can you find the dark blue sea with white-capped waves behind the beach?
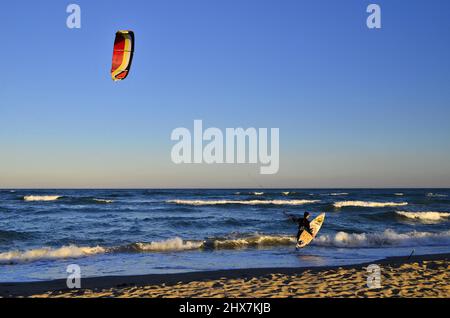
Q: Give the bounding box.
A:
[0,189,450,282]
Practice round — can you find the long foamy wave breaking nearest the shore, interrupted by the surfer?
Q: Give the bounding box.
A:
[0,229,450,264]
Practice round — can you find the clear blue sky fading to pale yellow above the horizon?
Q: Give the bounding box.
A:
[0,0,450,188]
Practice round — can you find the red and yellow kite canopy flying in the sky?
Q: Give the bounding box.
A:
[111,31,134,81]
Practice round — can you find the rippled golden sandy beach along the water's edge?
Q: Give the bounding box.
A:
[0,254,450,298]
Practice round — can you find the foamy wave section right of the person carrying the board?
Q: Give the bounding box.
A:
[312,229,450,247]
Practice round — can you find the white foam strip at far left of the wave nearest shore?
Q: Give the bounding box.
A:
[0,245,106,264]
